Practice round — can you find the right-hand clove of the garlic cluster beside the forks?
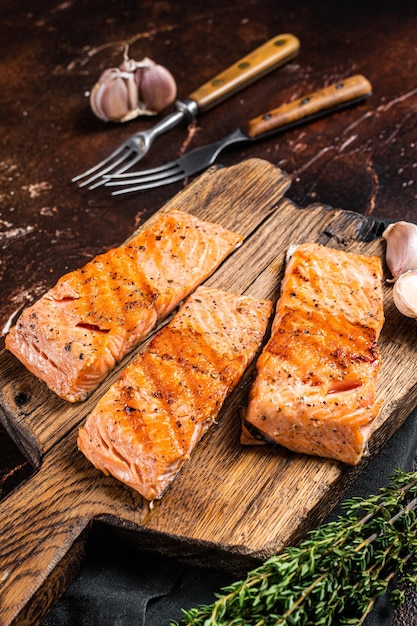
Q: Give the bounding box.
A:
[137,64,177,113]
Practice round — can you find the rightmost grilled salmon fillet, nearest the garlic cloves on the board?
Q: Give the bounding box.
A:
[241,244,384,465]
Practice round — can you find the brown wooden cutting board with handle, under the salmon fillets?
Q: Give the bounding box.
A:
[0,159,417,626]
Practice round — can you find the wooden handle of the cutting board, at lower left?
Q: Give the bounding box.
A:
[0,436,147,626]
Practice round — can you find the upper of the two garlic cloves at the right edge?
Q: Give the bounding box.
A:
[382,222,417,282]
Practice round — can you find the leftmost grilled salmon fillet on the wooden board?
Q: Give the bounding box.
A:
[6,209,242,402]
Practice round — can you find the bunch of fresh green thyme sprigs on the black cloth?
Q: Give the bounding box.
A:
[171,470,417,626]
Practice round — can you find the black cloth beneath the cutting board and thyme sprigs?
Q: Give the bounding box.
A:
[43,412,417,626]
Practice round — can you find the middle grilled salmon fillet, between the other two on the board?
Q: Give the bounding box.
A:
[78,287,272,500]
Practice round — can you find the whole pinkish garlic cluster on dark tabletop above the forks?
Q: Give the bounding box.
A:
[90,48,177,122]
